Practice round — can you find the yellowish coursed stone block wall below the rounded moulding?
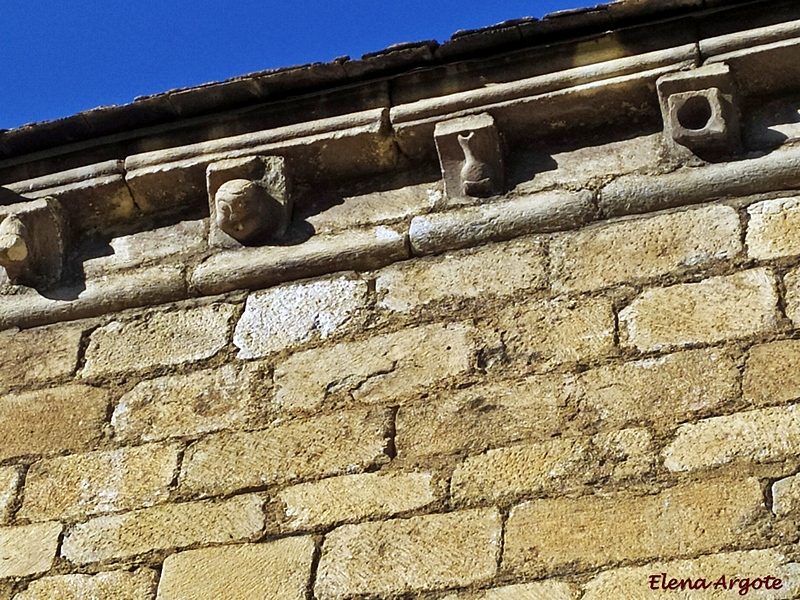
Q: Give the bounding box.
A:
[0,197,800,600]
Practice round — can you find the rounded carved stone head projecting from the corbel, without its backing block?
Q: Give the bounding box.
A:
[214,179,275,243]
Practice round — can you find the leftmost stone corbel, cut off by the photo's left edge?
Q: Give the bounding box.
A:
[0,198,67,289]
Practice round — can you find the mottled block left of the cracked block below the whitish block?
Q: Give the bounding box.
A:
[111,363,270,442]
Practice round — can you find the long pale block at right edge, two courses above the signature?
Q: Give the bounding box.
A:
[664,404,800,471]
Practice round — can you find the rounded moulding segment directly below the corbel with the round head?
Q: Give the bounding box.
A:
[191,226,409,295]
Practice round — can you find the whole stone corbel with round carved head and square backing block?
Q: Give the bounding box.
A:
[206,156,292,248]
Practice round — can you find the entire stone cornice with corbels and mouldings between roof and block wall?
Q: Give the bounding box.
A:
[0,2,800,328]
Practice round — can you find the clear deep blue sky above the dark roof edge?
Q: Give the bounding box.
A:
[0,0,594,129]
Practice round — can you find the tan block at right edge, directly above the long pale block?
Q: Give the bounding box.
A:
[742,340,800,406]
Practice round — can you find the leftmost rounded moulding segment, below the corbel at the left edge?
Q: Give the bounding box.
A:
[0,266,187,329]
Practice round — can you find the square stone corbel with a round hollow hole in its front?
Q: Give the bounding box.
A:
[656,64,742,160]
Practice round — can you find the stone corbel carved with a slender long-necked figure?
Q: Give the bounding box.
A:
[434,113,505,200]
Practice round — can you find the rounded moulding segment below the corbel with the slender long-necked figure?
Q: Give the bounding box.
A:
[409,191,596,256]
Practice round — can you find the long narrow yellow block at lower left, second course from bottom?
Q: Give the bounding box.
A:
[61,494,264,563]
